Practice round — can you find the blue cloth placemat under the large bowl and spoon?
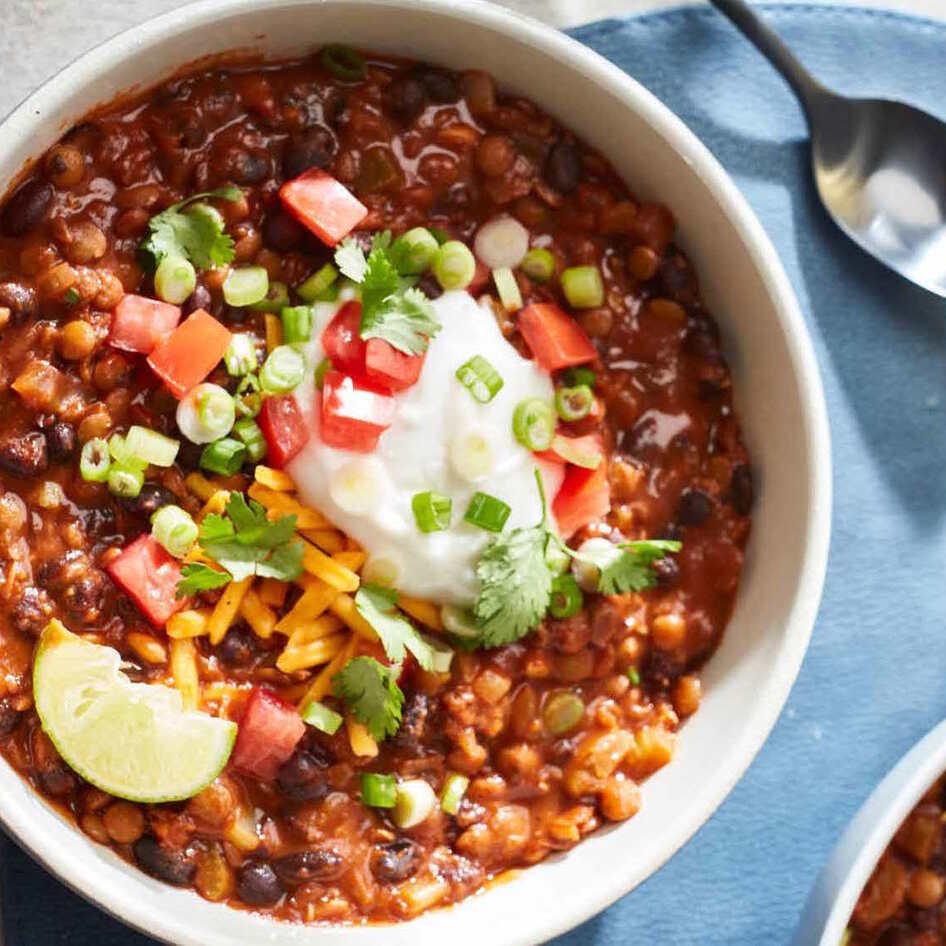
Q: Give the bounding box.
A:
[2,6,946,946]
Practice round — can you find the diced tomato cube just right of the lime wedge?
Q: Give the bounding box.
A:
[230,687,305,781]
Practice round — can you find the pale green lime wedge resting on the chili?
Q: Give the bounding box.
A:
[33,621,237,803]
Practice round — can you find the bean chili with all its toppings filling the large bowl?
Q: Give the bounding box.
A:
[0,4,817,942]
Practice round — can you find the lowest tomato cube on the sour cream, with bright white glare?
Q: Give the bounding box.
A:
[322,371,397,453]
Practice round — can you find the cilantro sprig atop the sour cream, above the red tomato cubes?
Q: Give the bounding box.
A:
[335,231,441,355]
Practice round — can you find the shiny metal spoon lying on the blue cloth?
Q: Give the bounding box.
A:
[710,0,946,297]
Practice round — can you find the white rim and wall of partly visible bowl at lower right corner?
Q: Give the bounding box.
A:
[792,722,946,946]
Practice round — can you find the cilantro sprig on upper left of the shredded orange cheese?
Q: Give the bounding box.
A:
[177,493,302,597]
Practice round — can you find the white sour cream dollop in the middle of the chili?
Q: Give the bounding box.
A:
[288,291,562,606]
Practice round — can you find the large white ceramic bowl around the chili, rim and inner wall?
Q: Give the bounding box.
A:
[0,0,830,946]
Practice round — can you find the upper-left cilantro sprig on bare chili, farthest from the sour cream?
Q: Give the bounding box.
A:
[141,185,243,269]
